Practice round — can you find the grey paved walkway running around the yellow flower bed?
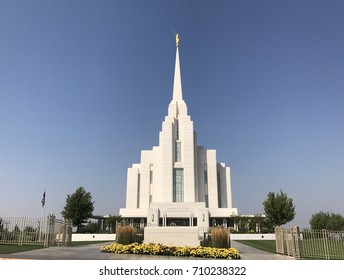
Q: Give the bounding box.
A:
[0,241,293,260]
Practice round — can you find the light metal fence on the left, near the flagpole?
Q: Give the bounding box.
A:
[0,215,72,247]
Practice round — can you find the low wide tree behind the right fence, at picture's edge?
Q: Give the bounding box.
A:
[309,211,344,230]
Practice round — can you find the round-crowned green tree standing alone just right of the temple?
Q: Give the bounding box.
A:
[263,191,295,227]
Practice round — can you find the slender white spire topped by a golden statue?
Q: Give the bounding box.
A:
[169,33,187,118]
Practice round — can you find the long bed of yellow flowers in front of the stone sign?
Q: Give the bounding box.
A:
[101,243,241,259]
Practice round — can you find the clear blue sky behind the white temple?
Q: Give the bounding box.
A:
[0,0,344,227]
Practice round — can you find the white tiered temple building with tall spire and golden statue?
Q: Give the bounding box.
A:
[119,34,238,227]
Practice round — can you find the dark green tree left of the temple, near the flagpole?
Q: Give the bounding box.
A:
[61,187,94,232]
